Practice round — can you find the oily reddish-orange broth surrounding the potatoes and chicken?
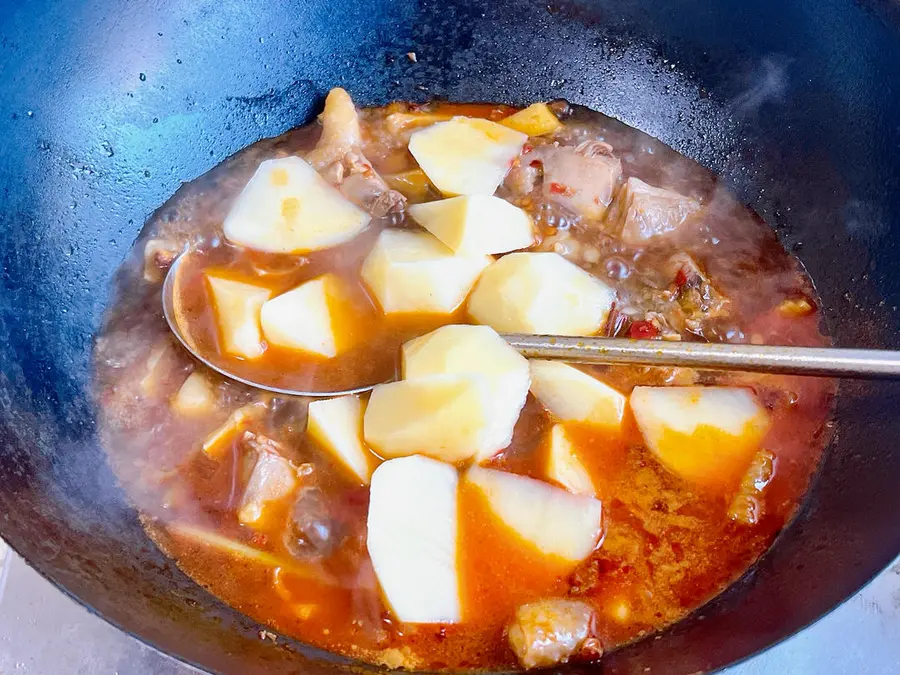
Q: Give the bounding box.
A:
[96,104,836,668]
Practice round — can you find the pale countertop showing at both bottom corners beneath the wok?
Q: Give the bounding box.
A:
[0,554,900,675]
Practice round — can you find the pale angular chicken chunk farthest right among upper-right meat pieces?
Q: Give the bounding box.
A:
[607,176,700,246]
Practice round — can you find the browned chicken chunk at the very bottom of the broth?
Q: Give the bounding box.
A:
[507,598,603,668]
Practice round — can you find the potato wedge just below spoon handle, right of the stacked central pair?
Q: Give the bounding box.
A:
[528,359,625,429]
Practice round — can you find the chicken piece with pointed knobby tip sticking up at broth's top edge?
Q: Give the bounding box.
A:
[306,87,406,217]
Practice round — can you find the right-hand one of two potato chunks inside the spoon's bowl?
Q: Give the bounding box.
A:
[260,274,341,359]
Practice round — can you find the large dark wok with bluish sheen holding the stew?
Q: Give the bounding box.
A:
[0,0,900,673]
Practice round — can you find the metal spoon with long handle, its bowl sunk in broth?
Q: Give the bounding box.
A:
[162,258,900,397]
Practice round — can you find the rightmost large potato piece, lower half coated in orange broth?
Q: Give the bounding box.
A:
[630,387,770,489]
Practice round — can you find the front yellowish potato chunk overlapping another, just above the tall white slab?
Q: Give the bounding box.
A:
[363,375,498,462]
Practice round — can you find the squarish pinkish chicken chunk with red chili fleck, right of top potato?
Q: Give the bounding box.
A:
[532,141,622,220]
